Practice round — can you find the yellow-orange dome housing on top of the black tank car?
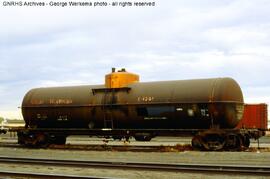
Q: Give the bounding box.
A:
[105,68,139,88]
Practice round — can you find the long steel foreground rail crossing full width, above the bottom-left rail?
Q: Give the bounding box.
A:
[0,156,270,176]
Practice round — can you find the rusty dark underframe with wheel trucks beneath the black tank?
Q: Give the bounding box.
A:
[9,128,265,151]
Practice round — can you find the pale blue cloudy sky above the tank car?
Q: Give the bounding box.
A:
[0,0,270,120]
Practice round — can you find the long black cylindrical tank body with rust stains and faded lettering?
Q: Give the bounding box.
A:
[22,78,243,129]
